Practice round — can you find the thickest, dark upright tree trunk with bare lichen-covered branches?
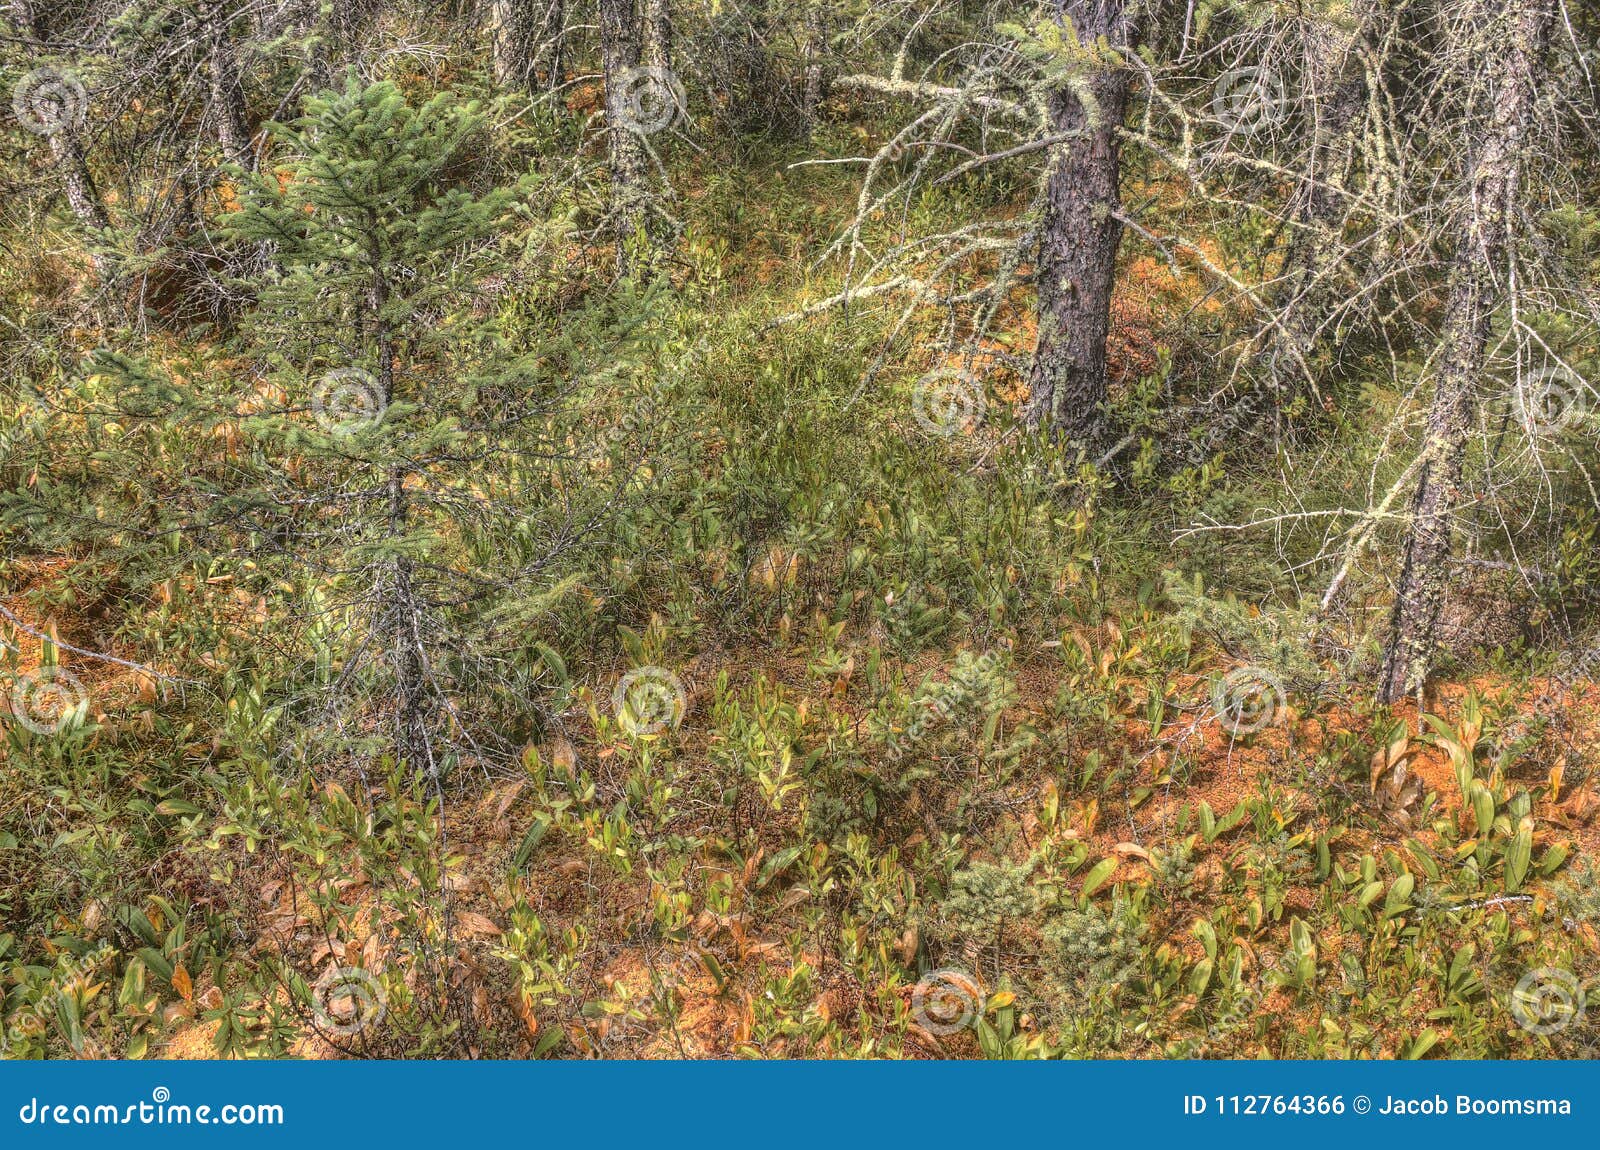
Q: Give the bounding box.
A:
[1027,0,1134,441]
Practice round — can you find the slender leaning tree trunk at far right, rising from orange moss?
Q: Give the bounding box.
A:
[1378,0,1554,702]
